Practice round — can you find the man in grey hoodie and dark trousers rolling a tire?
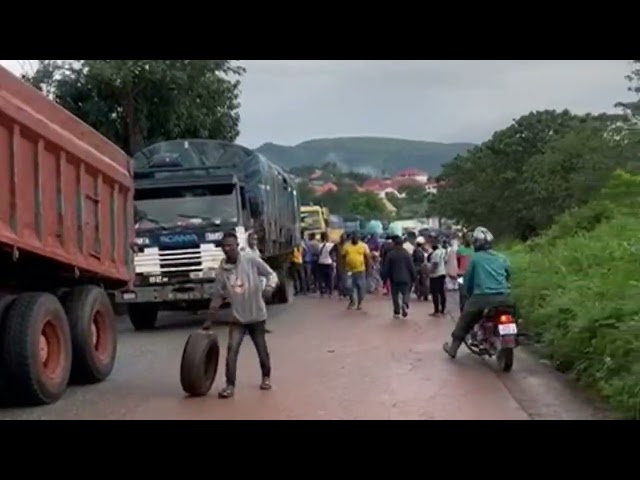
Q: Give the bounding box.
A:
[203,232,278,398]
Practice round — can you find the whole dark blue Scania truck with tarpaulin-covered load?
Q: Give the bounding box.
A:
[118,139,301,330]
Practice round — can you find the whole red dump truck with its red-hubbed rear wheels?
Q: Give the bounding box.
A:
[0,67,135,405]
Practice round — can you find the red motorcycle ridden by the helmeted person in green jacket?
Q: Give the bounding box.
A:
[458,279,519,372]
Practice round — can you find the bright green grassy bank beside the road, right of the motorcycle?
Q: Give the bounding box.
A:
[508,172,640,419]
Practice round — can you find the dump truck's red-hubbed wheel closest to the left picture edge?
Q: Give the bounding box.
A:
[0,293,72,406]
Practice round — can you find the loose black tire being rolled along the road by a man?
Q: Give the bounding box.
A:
[180,330,220,397]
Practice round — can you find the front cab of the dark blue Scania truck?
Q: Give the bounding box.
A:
[120,141,252,329]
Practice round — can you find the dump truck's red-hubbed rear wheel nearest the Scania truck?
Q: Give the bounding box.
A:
[64,285,118,384]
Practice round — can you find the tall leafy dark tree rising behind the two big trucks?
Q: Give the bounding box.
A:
[23,60,244,155]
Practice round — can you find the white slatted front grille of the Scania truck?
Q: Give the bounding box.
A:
[134,244,224,275]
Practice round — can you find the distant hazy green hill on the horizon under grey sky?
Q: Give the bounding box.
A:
[257,137,474,175]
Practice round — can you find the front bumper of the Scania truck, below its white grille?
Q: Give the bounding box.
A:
[115,282,215,304]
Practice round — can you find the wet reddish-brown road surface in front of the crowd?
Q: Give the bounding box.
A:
[0,295,606,420]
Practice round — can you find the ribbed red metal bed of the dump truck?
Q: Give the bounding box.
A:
[0,67,134,286]
